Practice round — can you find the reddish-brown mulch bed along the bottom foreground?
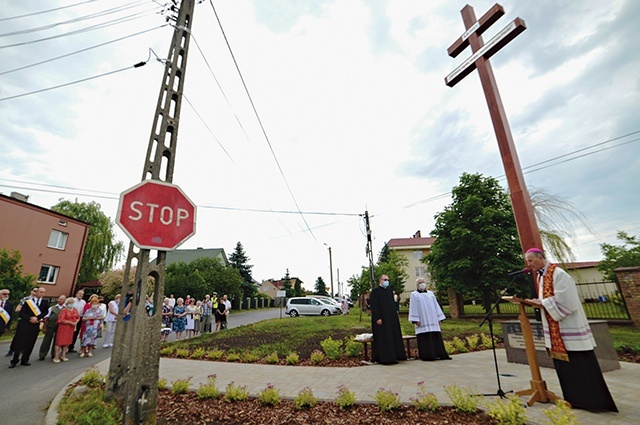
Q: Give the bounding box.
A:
[156,390,496,425]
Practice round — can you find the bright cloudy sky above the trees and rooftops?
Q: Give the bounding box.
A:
[0,0,640,288]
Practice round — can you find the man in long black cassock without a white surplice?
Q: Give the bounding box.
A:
[370,274,407,364]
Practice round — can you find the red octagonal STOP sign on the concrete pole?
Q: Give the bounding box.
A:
[117,180,196,251]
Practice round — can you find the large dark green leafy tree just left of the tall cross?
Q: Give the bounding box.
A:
[426,173,528,311]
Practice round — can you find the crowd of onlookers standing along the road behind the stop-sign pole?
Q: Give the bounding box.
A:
[0,287,231,369]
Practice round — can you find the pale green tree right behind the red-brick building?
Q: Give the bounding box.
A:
[51,199,124,283]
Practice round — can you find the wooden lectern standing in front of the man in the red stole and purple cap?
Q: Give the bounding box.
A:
[502,296,566,406]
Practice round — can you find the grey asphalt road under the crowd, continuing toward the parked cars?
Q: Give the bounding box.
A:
[0,308,288,425]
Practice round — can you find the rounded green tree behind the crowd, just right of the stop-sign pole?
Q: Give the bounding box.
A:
[165,258,242,300]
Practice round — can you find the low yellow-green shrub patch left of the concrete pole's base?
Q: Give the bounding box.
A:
[57,387,122,425]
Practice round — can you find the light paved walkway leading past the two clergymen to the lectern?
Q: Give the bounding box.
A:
[51,350,640,425]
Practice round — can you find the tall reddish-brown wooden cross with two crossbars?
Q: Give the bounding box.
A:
[445,4,542,253]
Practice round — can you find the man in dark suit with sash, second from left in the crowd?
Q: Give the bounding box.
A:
[9,288,49,369]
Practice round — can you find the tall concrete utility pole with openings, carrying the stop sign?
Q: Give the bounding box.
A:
[107,0,195,425]
